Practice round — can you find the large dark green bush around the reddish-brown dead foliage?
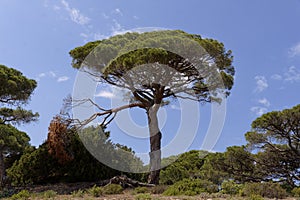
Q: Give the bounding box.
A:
[7,127,143,186]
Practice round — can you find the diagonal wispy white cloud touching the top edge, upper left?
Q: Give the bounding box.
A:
[61,0,91,25]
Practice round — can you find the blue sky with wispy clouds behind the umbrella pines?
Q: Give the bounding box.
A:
[0,0,300,156]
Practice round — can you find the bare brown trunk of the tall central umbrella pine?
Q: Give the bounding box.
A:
[147,104,162,185]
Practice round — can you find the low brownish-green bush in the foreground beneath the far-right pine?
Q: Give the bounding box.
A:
[240,182,287,199]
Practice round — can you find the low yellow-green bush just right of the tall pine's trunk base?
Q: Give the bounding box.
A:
[163,179,218,196]
